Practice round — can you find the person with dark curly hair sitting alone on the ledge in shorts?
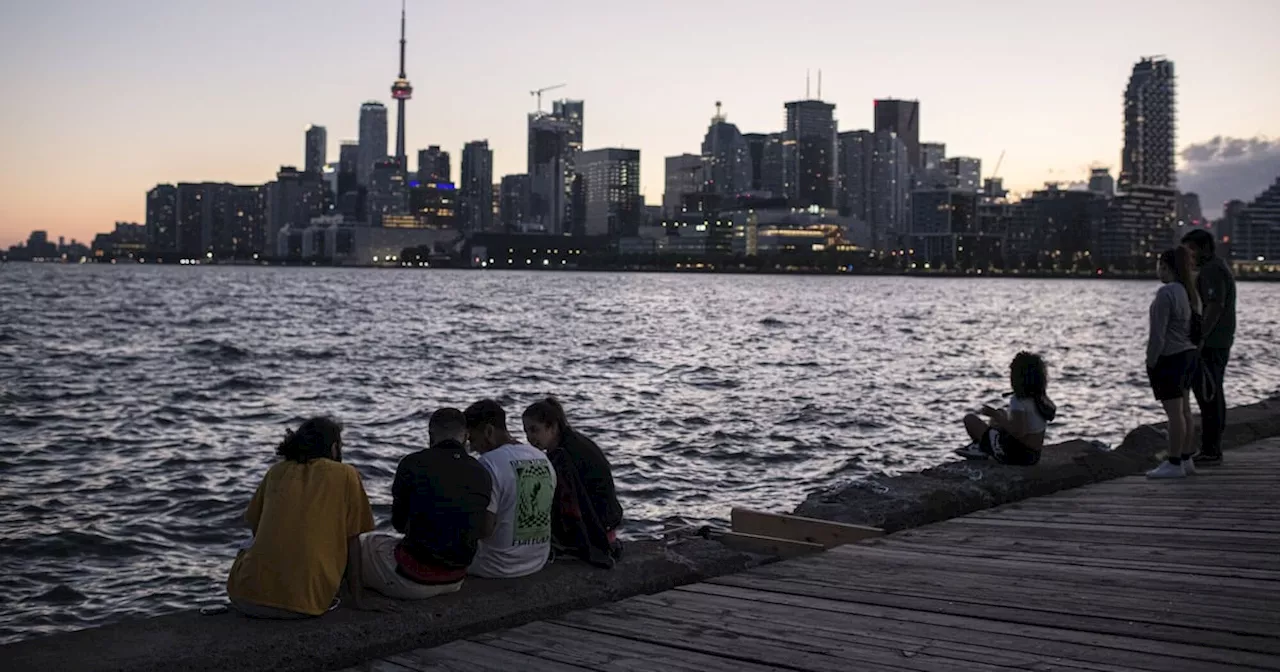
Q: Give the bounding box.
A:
[956,352,1057,466]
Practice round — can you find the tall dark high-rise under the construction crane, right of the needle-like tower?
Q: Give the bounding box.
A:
[527,109,582,236]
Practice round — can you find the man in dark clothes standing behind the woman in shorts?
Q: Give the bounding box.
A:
[1183,229,1235,465]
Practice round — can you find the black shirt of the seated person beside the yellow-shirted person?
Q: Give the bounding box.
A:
[392,440,493,570]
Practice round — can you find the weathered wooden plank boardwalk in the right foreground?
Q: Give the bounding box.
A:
[352,439,1280,672]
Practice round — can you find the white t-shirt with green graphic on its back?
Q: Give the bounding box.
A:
[467,443,556,579]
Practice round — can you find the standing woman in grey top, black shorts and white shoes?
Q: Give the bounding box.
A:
[1147,247,1201,479]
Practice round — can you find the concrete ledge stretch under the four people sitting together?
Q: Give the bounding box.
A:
[0,539,760,672]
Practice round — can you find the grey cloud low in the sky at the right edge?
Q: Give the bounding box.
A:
[1178,136,1280,218]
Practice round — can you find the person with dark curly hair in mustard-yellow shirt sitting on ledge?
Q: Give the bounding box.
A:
[227,417,374,618]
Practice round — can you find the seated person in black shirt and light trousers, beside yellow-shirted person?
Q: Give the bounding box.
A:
[360,408,493,599]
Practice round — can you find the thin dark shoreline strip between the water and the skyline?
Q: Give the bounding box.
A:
[0,259,1280,283]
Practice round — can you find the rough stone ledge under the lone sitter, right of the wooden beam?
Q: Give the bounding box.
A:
[795,398,1280,532]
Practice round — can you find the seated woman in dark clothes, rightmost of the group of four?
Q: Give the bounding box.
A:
[522,397,622,567]
